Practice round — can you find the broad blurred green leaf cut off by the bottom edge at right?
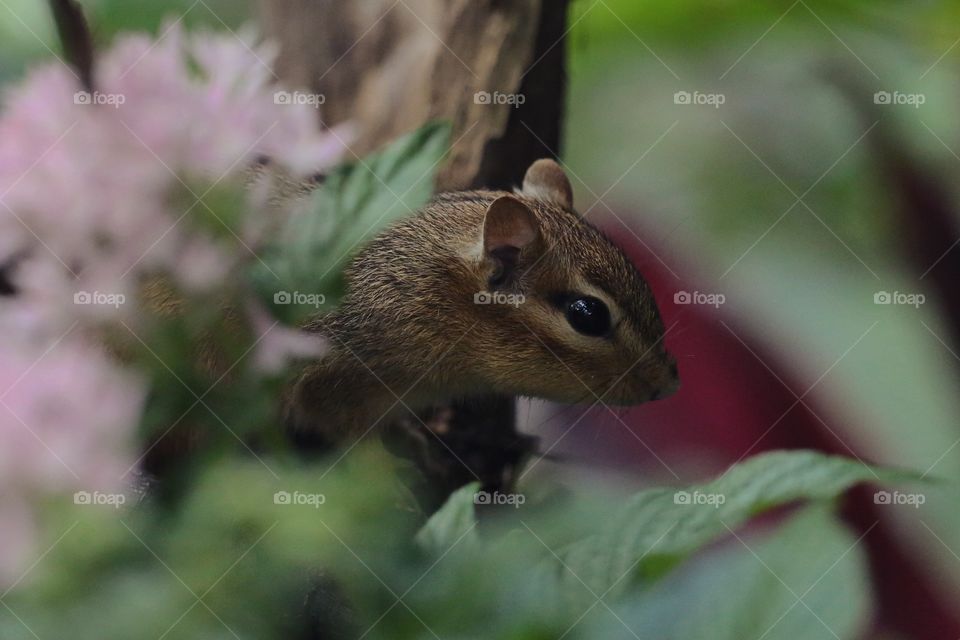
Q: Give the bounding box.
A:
[582,507,870,640]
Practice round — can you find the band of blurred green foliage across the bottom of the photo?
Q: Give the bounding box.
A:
[0,447,909,640]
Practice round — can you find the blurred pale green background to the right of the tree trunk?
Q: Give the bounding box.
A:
[565,0,960,620]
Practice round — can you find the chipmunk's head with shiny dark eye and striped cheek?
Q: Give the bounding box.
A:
[474,160,679,404]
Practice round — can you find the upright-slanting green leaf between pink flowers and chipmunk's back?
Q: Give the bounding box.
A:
[253,123,450,324]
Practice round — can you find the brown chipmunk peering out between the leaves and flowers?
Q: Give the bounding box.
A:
[289,159,679,441]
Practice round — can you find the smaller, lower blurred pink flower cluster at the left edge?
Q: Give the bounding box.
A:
[0,337,144,589]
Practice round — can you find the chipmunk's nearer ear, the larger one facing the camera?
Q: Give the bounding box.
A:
[483,196,540,287]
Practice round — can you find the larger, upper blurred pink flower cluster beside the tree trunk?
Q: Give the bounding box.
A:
[0,21,344,311]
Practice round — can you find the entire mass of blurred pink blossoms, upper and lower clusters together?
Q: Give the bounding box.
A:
[0,26,343,586]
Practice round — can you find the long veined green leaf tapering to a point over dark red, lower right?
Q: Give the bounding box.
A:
[560,451,917,601]
